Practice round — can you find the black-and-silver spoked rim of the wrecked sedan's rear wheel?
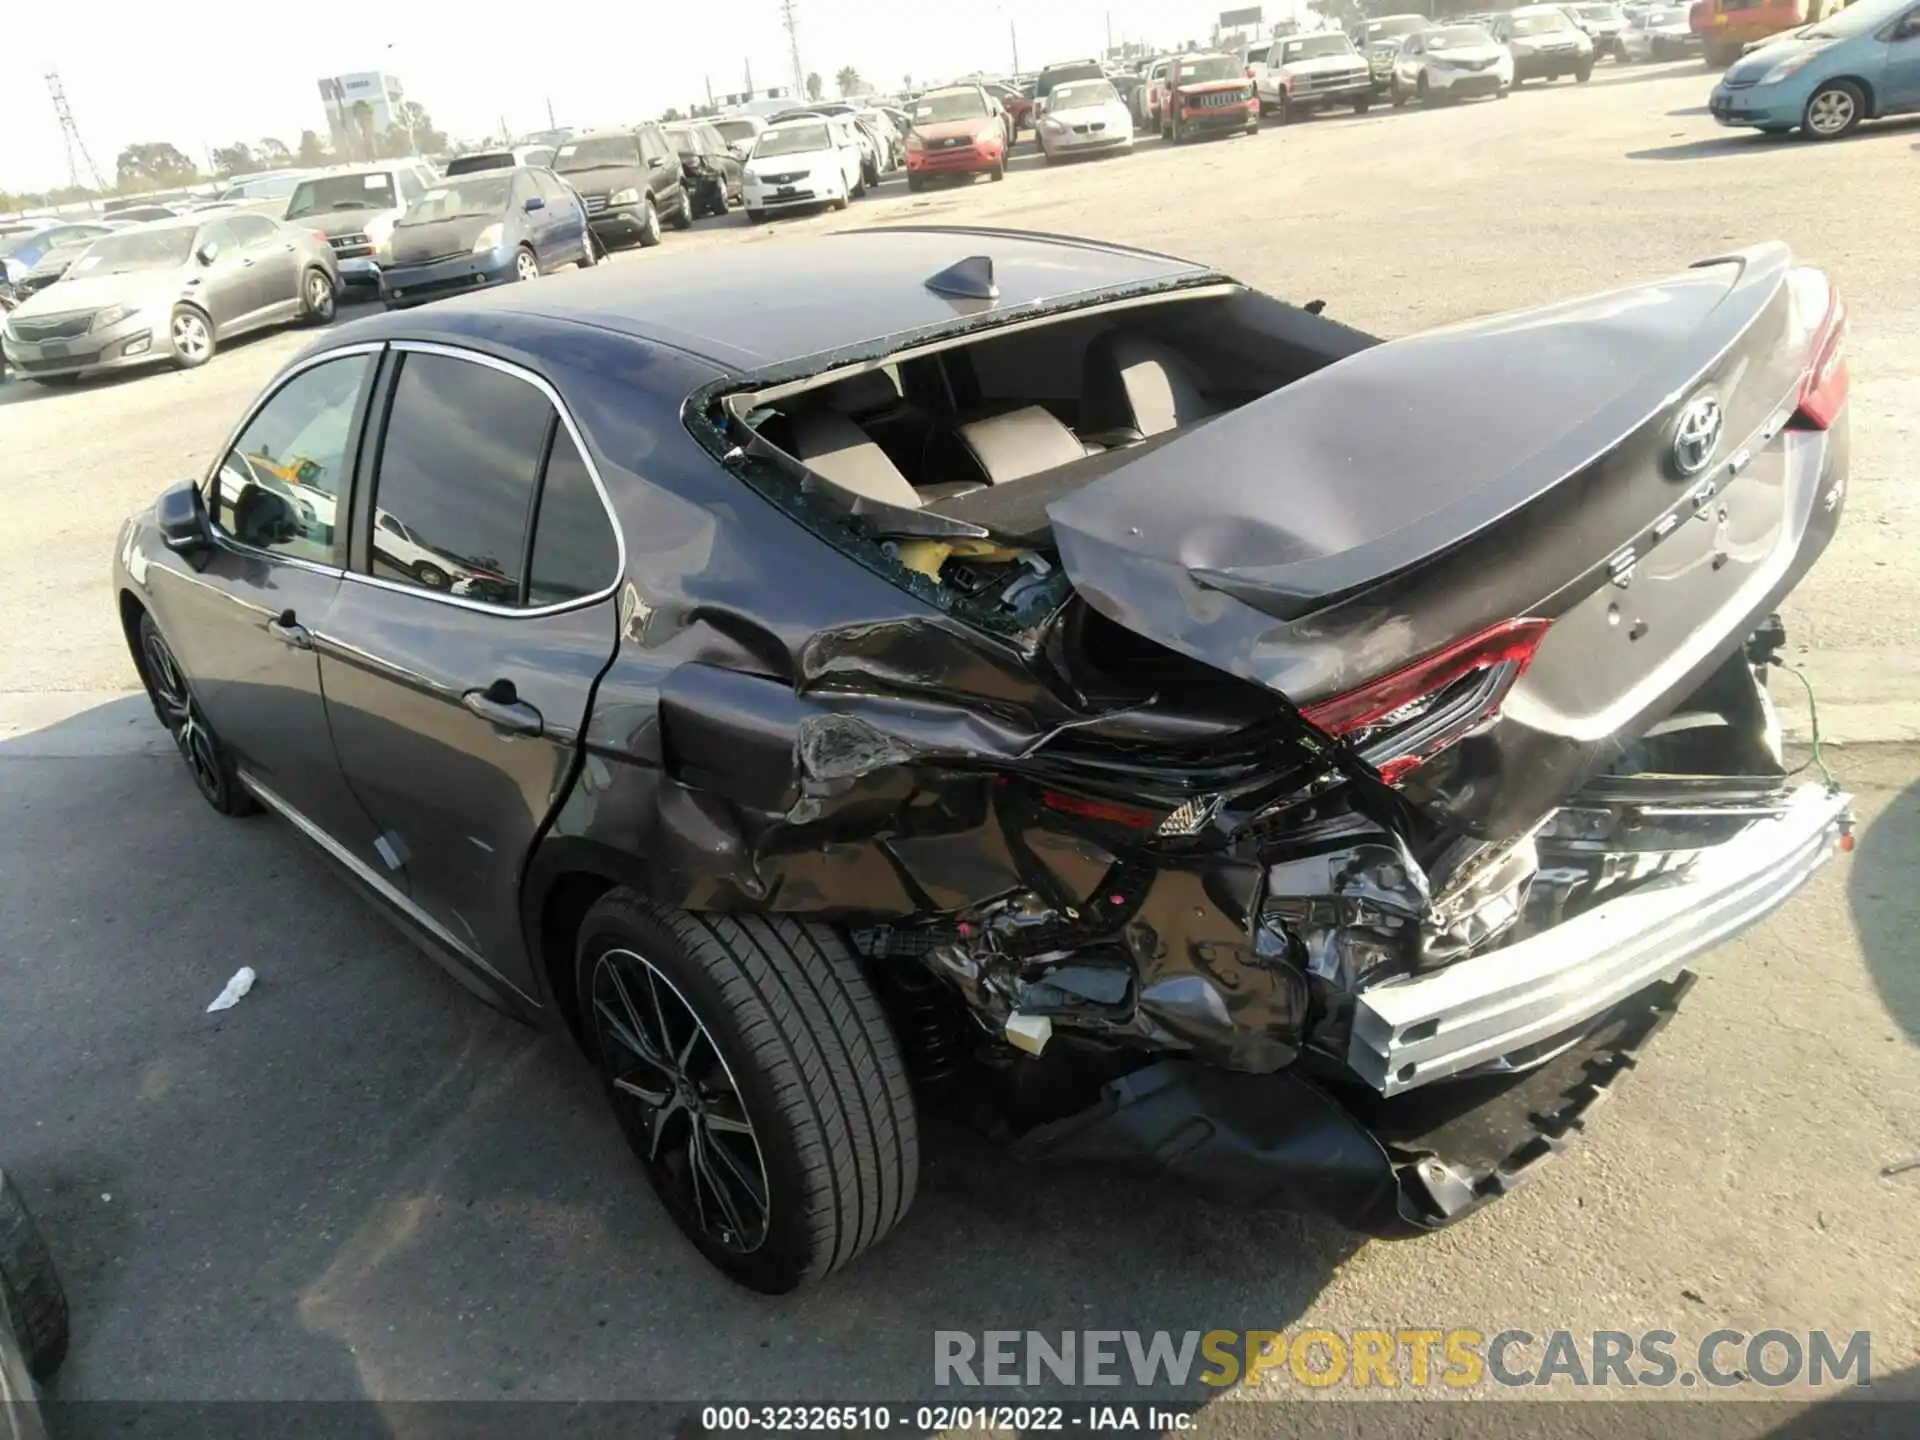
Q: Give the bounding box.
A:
[591,948,770,1256]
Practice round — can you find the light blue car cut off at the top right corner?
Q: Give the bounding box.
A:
[1707,0,1920,140]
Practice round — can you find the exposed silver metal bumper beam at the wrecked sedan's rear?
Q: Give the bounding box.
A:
[1348,785,1853,1096]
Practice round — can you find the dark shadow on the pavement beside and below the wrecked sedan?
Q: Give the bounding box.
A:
[0,697,1352,1402]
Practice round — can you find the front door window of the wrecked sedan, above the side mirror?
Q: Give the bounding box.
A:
[207,355,374,564]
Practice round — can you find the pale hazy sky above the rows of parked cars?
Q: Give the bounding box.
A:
[0,0,1320,190]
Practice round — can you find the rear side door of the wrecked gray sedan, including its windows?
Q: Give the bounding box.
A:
[321,342,620,995]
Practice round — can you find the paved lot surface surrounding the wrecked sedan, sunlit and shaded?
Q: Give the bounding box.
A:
[0,65,1920,1434]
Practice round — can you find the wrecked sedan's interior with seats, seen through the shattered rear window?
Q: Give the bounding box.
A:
[735,288,1375,545]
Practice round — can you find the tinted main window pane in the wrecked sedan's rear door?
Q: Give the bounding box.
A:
[371,353,553,605]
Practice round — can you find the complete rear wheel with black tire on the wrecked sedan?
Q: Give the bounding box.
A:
[574,889,920,1294]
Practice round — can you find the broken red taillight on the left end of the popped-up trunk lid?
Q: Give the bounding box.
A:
[1300,618,1551,783]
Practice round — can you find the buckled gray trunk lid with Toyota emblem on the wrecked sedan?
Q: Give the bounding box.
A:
[1048,246,1843,833]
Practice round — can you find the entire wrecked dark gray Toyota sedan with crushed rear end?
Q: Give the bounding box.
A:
[115,230,1851,1292]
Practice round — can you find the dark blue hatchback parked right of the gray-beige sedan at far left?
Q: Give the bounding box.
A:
[378,165,599,309]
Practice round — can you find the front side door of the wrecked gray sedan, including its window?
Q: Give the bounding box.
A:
[150,346,393,860]
